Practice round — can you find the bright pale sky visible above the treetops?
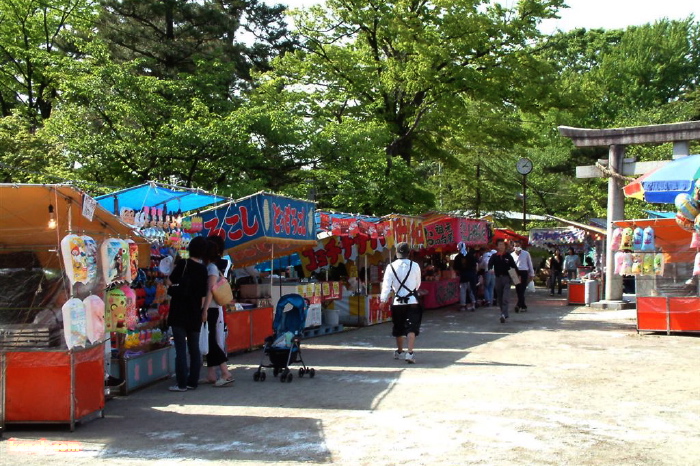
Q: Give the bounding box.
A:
[264,0,700,34]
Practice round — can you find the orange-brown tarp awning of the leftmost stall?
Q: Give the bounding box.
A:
[0,184,150,266]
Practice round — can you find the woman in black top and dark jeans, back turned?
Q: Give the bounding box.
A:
[168,237,207,392]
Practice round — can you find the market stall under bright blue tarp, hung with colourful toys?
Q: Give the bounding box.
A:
[96,182,225,394]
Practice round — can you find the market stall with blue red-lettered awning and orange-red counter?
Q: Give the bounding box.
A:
[201,192,316,352]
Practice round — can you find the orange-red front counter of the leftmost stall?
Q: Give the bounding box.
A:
[0,345,105,431]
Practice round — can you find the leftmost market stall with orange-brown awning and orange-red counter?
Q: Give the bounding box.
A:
[0,184,149,429]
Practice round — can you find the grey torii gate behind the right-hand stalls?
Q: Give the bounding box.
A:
[559,121,700,309]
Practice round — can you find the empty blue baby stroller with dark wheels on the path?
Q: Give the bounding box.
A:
[253,294,316,383]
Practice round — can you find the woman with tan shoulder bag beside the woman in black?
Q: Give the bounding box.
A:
[200,236,234,387]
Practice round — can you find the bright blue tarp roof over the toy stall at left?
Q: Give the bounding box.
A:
[96,182,227,215]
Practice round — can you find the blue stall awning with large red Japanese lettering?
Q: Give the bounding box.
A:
[200,192,316,267]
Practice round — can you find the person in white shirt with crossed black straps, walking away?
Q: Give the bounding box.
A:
[380,242,423,364]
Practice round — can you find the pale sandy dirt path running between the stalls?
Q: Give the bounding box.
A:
[0,290,700,465]
